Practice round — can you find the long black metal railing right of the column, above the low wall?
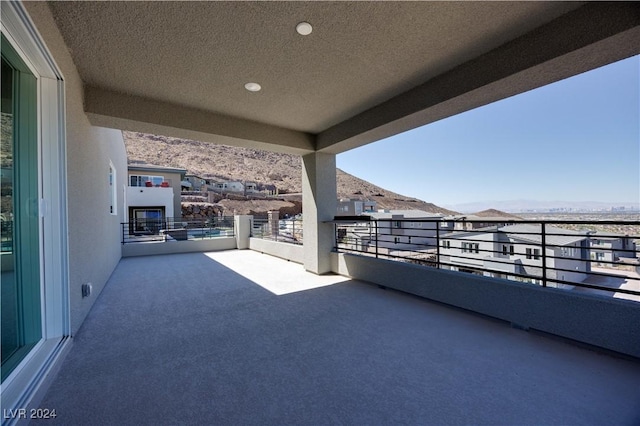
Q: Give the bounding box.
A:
[335,220,640,301]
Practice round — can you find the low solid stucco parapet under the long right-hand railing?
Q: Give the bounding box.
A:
[332,253,640,358]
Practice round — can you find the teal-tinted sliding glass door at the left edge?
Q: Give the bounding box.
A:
[0,36,42,381]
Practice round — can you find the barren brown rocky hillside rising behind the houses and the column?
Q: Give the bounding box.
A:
[123,132,455,214]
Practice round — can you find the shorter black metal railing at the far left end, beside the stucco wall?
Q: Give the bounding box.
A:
[120,216,234,244]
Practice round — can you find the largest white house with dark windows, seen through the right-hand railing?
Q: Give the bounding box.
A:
[440,224,591,282]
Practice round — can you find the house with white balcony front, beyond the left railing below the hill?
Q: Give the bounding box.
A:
[124,165,187,223]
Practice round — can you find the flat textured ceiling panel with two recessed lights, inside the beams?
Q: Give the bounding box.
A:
[49,1,636,155]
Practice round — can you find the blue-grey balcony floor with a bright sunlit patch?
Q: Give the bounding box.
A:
[39,250,640,425]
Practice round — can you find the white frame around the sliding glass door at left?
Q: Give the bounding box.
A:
[0,1,70,414]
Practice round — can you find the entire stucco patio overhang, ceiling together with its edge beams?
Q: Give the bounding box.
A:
[49,2,640,155]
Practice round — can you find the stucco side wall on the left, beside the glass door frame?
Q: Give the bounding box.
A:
[24,2,127,334]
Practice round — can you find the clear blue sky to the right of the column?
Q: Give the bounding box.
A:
[337,56,640,205]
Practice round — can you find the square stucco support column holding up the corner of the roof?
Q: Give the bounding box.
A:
[302,152,337,274]
